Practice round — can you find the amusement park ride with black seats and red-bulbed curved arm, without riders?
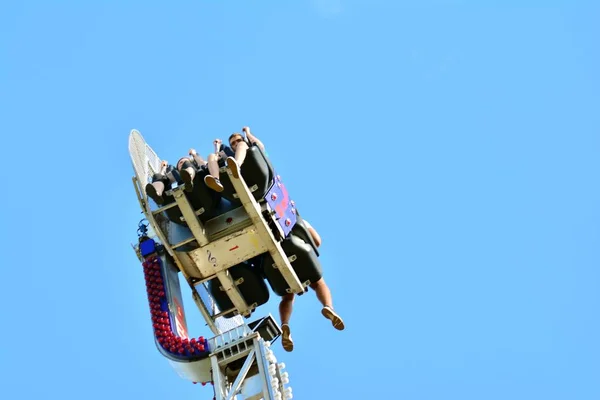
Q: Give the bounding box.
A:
[129,130,321,400]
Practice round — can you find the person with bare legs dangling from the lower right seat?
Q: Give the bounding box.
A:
[279,219,345,351]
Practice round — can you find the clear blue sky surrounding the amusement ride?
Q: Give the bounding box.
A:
[0,0,600,400]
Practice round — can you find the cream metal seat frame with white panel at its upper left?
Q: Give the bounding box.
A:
[130,130,306,324]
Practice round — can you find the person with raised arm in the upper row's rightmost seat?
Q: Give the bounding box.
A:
[204,126,265,192]
